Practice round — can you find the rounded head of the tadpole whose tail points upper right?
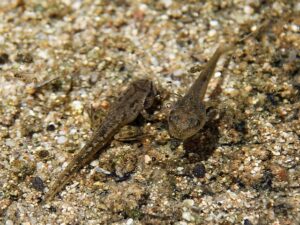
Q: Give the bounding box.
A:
[168,104,206,140]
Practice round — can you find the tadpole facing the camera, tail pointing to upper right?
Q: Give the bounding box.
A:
[168,45,234,140]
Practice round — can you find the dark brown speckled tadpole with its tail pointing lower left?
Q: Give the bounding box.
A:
[44,79,156,202]
